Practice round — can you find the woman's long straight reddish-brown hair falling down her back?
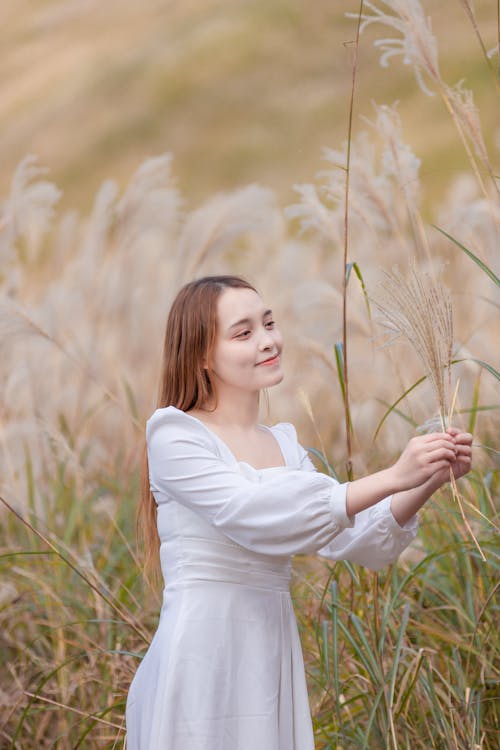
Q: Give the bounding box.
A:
[136,276,257,580]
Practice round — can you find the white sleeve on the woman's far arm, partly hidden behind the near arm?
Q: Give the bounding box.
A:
[298,443,418,570]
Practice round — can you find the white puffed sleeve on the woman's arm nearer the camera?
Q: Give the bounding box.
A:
[146,406,353,555]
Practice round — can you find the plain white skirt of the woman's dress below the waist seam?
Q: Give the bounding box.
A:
[126,576,314,750]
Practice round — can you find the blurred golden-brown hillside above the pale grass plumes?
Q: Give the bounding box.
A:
[0,0,500,210]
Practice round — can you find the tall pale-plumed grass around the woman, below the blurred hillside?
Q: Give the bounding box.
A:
[0,1,500,750]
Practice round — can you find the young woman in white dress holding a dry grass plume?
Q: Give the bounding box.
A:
[126,276,471,750]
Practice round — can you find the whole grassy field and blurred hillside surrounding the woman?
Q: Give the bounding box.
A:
[0,0,500,750]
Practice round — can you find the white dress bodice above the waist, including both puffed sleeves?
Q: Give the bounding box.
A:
[146,406,417,572]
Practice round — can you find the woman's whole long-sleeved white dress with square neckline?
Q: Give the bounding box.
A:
[126,406,417,750]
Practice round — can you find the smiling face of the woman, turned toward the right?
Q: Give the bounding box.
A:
[208,288,283,392]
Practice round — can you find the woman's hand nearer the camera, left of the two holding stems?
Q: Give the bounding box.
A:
[389,432,457,492]
